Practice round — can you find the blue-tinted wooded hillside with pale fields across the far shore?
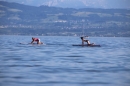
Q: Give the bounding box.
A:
[0,1,130,37]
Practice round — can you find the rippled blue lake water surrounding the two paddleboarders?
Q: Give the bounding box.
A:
[0,36,130,86]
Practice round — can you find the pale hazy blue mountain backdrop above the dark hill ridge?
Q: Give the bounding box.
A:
[0,0,130,8]
